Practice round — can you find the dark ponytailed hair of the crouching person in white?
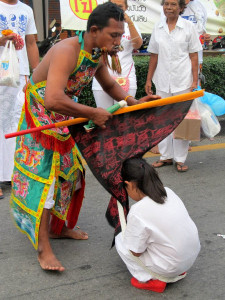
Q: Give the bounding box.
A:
[121,158,167,204]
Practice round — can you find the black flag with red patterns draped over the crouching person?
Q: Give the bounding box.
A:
[69,101,192,234]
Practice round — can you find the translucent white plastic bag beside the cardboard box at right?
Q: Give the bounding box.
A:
[196,99,221,138]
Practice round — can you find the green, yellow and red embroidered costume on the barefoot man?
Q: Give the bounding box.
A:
[10,50,98,249]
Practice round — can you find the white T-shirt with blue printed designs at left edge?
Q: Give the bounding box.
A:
[0,1,37,75]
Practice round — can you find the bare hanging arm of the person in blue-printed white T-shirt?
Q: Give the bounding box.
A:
[25,34,39,70]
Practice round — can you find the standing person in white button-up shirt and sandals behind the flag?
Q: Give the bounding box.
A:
[145,0,202,172]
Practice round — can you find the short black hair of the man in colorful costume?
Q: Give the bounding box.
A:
[87,2,124,31]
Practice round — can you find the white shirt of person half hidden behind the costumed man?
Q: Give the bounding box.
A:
[92,23,141,90]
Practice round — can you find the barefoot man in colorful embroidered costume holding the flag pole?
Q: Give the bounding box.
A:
[11,2,158,271]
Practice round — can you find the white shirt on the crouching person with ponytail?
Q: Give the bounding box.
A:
[124,188,200,277]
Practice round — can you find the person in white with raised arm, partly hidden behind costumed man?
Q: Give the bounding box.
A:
[92,0,143,109]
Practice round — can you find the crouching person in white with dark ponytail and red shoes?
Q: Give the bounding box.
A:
[115,158,200,293]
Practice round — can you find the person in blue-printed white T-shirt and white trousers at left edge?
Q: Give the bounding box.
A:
[0,0,39,198]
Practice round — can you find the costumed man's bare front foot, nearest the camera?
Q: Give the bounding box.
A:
[38,251,65,272]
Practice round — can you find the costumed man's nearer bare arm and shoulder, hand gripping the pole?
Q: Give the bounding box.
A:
[41,43,112,128]
